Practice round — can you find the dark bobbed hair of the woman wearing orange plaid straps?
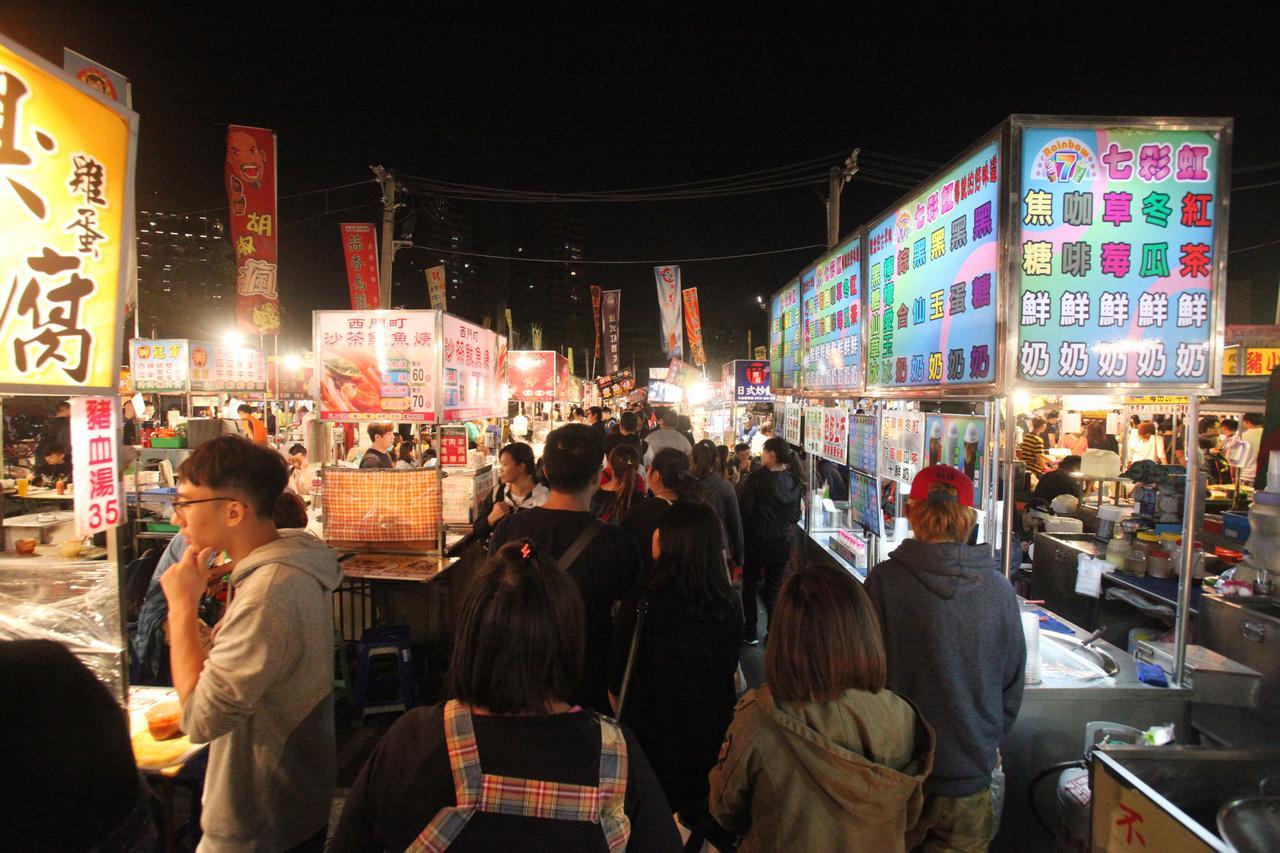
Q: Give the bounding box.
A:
[445,539,584,715]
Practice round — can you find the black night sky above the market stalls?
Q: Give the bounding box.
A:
[0,1,1280,366]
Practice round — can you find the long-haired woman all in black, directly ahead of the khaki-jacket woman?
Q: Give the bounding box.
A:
[609,501,742,829]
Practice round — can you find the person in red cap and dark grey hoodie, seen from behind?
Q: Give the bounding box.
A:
[867,465,1027,850]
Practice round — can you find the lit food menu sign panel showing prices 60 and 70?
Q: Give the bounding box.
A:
[312,311,436,423]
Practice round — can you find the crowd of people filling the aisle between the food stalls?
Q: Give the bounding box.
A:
[5,404,1024,850]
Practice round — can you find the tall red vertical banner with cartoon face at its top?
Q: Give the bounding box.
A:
[227,124,280,334]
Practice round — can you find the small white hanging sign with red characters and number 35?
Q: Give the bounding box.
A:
[70,397,124,537]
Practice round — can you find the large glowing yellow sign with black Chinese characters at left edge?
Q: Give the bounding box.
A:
[0,38,138,394]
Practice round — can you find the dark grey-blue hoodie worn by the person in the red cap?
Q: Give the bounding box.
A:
[867,539,1027,797]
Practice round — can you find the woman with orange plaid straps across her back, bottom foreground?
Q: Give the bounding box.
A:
[329,539,680,853]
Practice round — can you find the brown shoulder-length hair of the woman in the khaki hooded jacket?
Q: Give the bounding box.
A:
[764,565,886,702]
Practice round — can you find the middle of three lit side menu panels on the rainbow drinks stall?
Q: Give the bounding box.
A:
[800,234,863,391]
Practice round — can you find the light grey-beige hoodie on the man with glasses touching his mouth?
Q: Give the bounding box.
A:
[182,530,342,853]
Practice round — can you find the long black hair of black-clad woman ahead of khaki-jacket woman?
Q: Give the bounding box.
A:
[645,501,737,617]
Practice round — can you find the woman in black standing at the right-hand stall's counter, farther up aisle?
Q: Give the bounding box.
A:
[739,435,804,646]
